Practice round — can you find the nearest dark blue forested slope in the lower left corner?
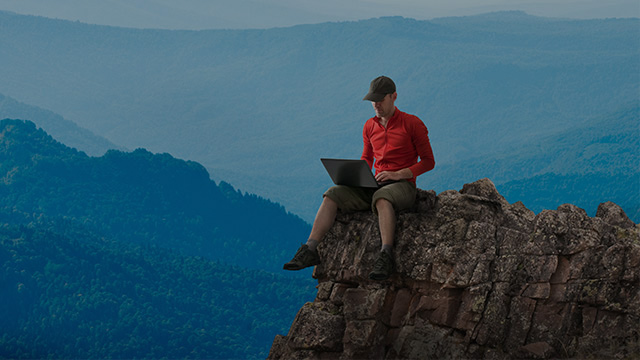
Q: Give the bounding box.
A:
[0,221,315,359]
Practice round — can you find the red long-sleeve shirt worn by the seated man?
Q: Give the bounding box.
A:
[361,108,436,184]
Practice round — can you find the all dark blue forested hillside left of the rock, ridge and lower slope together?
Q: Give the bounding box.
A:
[0,119,315,359]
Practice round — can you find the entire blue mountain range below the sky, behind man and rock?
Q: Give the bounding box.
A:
[0,11,640,358]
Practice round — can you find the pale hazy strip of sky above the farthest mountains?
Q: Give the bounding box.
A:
[0,0,640,29]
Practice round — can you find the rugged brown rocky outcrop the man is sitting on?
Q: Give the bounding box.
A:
[269,179,640,359]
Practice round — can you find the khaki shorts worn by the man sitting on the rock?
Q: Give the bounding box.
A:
[324,180,417,214]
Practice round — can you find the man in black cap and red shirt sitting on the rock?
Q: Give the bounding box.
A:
[284,76,435,280]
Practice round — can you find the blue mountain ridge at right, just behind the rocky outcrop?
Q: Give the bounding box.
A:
[434,102,640,223]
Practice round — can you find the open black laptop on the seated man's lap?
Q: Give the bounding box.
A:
[320,158,395,188]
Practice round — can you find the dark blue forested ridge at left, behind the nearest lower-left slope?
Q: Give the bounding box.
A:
[0,119,309,271]
